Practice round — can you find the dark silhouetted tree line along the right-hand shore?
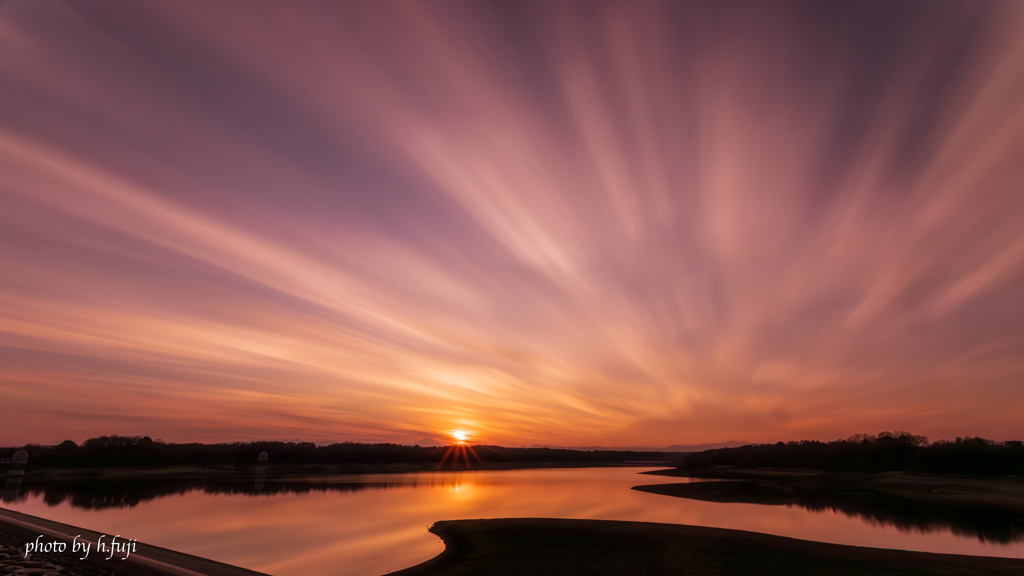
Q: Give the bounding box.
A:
[680,430,1024,476]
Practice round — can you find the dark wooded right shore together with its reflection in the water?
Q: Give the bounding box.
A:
[635,431,1024,543]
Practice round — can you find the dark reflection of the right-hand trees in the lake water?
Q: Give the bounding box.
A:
[634,481,1024,544]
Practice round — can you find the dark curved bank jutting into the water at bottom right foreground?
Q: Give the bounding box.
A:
[395,519,1024,576]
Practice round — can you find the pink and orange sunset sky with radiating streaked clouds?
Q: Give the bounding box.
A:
[0,0,1024,446]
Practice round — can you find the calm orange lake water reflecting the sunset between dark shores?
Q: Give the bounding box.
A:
[2,468,1024,576]
